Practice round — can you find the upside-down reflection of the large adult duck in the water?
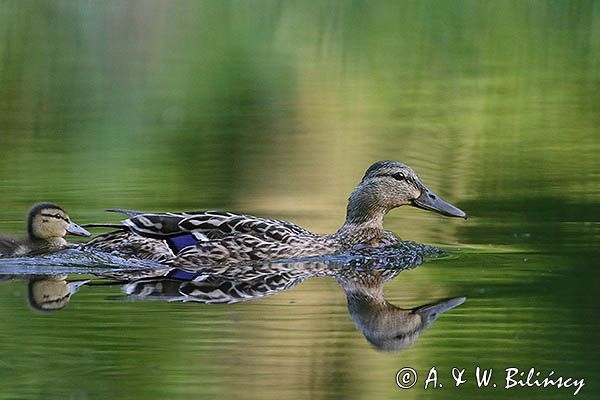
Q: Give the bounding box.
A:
[102,262,466,351]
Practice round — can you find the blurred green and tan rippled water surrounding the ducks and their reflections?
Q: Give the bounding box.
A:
[0,0,600,398]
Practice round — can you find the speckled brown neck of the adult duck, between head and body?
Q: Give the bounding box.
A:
[335,185,388,245]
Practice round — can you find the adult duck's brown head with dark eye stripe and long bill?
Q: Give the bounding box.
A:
[347,161,467,222]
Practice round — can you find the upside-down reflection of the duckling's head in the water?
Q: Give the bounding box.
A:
[27,275,90,312]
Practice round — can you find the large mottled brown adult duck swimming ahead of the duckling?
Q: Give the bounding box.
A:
[84,161,466,268]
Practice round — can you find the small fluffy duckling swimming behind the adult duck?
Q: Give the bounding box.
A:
[0,203,91,256]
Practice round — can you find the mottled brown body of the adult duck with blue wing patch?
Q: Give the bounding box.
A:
[86,210,337,267]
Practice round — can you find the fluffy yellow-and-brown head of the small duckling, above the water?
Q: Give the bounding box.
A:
[27,203,91,241]
